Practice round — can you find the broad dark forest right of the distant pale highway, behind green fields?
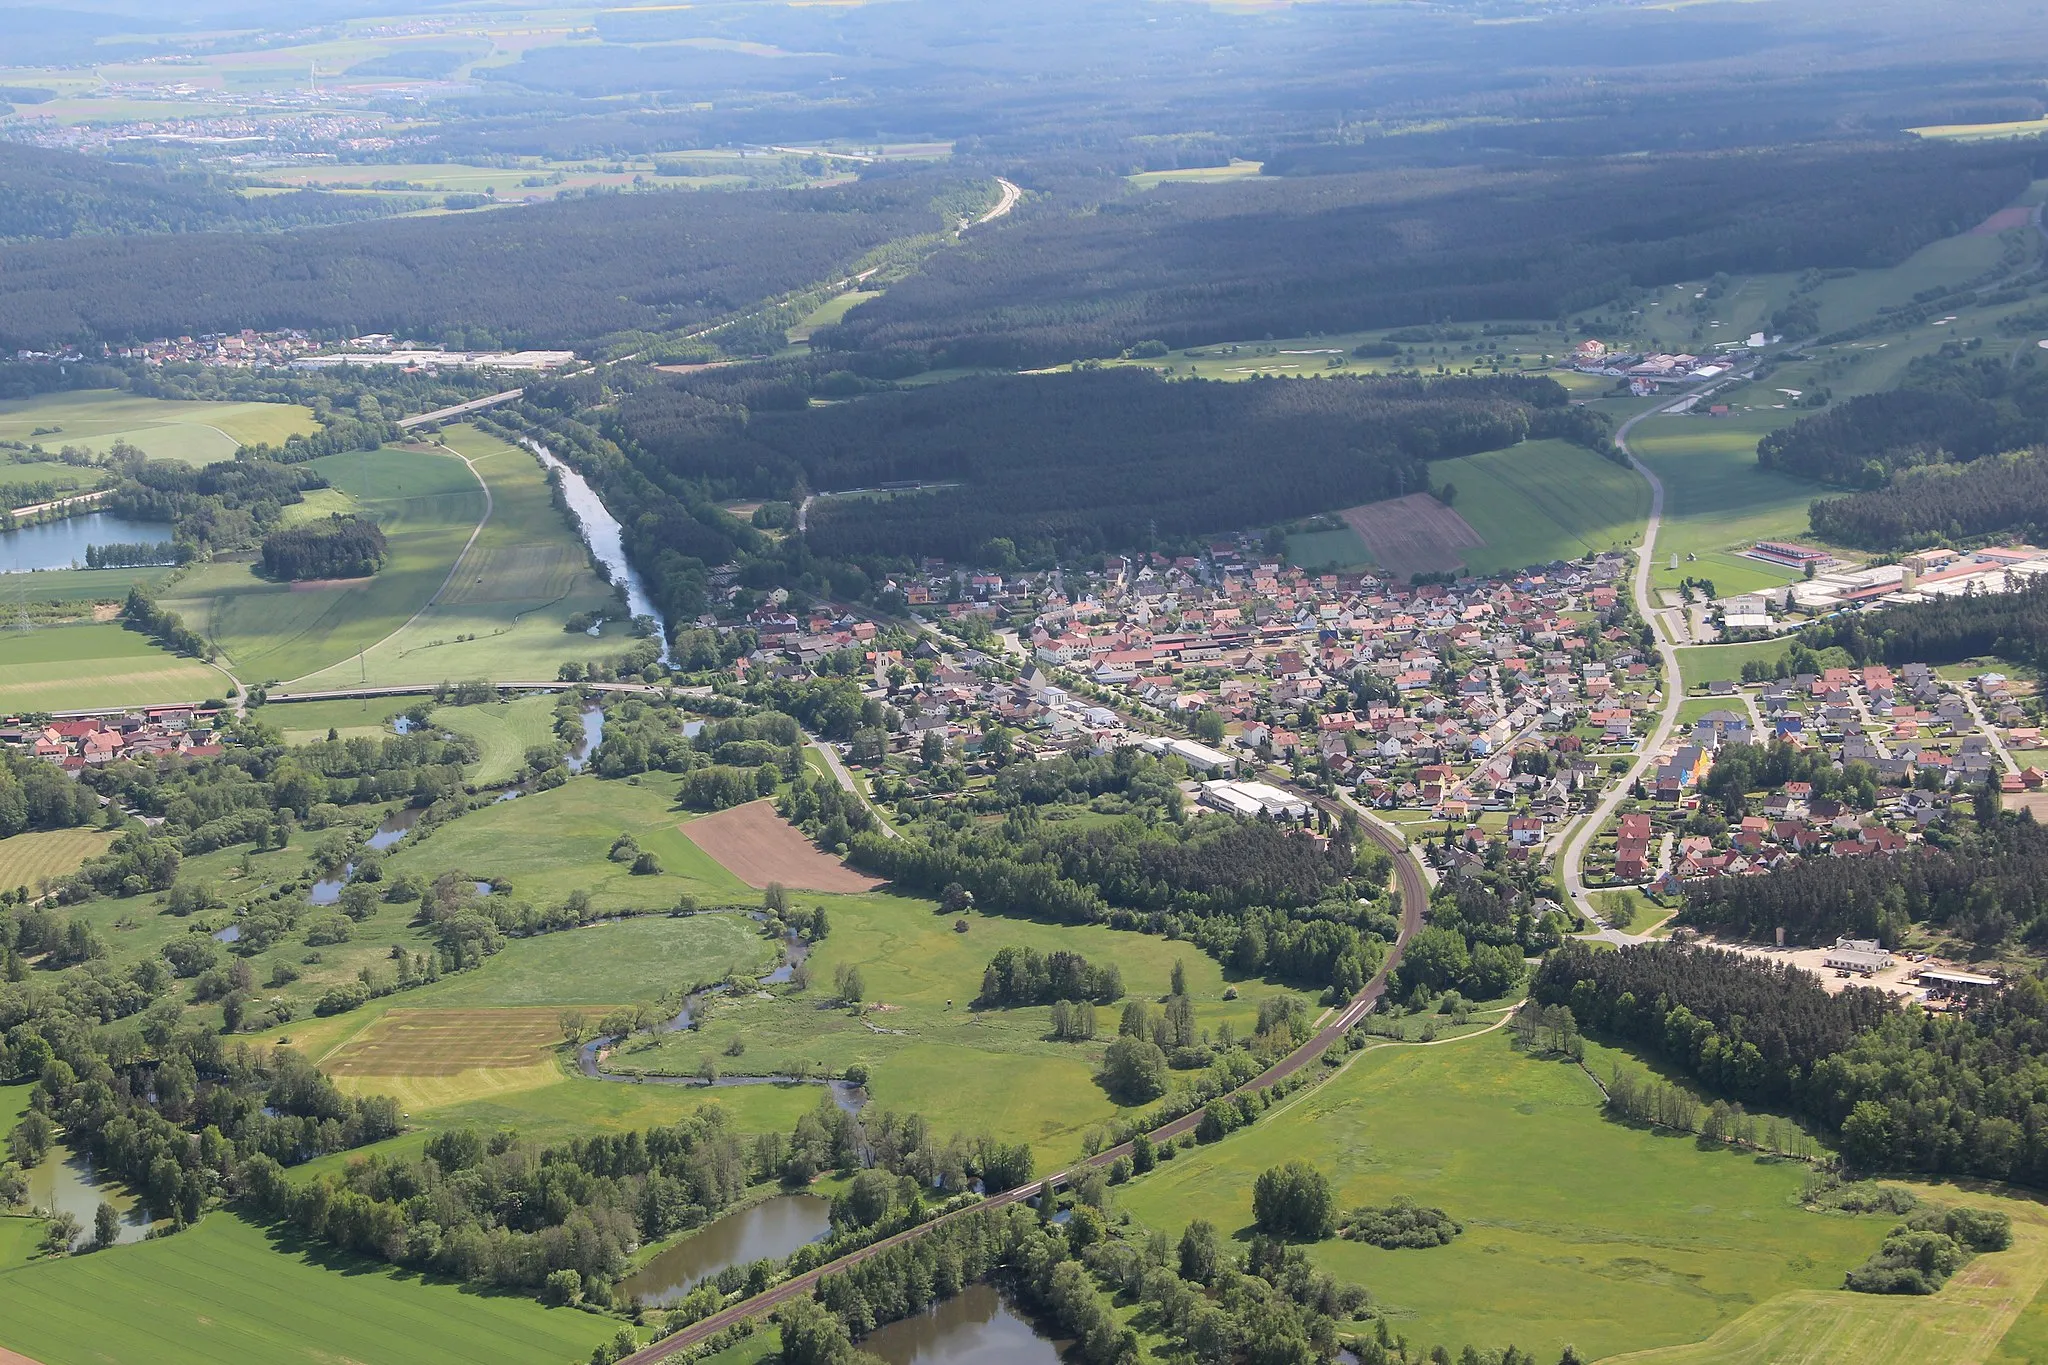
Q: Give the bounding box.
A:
[813,147,2038,366]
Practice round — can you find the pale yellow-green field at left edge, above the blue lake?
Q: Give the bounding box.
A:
[0,389,319,465]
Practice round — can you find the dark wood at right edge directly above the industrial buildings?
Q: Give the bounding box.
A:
[1808,446,2048,551]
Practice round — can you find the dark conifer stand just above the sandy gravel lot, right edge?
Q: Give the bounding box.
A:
[1679,817,2048,950]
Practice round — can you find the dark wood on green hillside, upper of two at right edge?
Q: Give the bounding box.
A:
[1757,342,2048,491]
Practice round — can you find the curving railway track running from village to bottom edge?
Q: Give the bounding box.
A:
[621,825,1430,1365]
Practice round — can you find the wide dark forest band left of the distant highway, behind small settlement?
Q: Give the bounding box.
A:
[0,172,950,348]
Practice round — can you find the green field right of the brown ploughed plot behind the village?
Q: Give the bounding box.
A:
[1430,440,1651,573]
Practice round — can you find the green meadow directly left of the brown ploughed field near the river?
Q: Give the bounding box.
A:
[385,774,760,911]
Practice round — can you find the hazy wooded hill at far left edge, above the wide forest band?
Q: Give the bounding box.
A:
[0,141,411,244]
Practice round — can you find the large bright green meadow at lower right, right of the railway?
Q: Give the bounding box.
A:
[1118,1029,1949,1365]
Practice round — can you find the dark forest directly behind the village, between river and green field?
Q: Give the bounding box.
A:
[606,370,1597,559]
